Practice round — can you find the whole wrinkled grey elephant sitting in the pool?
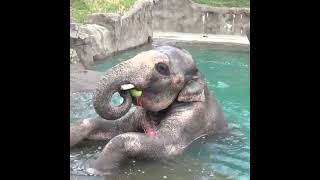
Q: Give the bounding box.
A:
[70,46,228,174]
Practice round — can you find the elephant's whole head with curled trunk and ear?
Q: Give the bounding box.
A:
[93,46,204,120]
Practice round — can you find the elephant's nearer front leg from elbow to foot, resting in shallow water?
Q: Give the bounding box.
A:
[88,132,185,175]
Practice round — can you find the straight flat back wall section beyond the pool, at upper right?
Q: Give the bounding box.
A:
[152,0,250,36]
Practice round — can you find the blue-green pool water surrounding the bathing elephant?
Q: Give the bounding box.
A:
[70,43,250,180]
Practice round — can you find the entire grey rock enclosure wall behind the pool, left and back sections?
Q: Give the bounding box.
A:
[70,0,250,69]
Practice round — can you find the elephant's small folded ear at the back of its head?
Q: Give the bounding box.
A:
[177,73,205,102]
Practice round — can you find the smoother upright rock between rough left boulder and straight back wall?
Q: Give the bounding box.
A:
[86,0,153,52]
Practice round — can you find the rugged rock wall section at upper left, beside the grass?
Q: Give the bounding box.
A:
[70,0,153,69]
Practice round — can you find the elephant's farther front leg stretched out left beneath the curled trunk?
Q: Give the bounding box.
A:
[70,109,144,147]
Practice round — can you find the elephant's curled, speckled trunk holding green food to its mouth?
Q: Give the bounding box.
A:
[93,53,152,120]
